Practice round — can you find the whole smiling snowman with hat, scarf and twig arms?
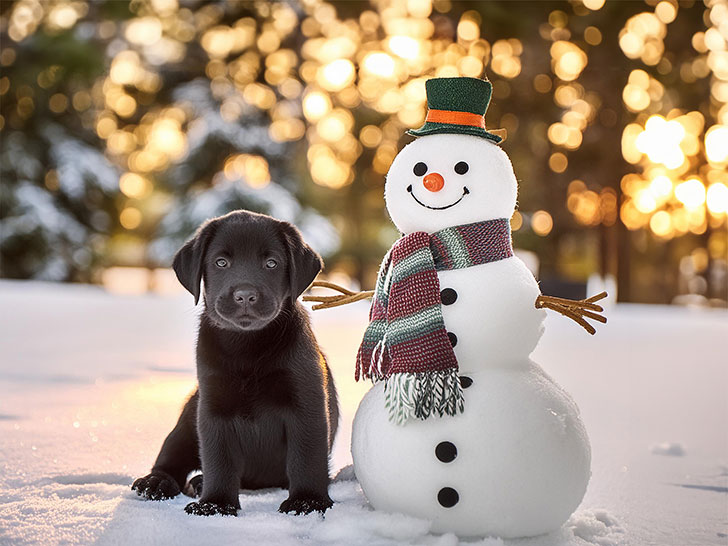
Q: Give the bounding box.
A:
[310,78,604,538]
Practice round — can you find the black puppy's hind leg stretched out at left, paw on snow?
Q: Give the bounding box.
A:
[131,392,201,500]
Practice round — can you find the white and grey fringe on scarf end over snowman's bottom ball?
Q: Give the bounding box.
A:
[384,369,465,425]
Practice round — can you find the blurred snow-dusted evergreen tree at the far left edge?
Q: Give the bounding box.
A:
[0,3,118,281]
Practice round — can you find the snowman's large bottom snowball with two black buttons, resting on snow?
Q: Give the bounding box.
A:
[351,363,591,538]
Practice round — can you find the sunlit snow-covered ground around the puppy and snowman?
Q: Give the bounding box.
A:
[0,282,728,546]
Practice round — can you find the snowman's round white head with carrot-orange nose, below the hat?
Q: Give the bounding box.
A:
[384,134,518,235]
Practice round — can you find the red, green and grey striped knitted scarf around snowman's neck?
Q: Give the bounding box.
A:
[356,218,513,425]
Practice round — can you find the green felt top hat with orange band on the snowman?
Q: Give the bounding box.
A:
[407,78,505,144]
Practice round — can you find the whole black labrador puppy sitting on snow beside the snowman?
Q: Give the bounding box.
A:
[132,211,339,515]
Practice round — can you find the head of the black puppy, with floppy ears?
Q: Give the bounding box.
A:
[173,211,323,331]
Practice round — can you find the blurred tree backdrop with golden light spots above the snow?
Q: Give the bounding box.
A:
[0,0,728,305]
